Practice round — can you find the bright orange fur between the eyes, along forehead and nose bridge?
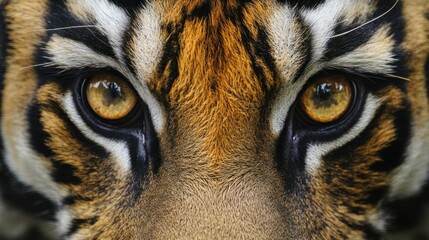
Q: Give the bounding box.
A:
[160,1,274,162]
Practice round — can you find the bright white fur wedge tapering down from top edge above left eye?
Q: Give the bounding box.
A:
[68,0,130,62]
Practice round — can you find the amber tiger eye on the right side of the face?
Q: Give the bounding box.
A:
[299,75,353,123]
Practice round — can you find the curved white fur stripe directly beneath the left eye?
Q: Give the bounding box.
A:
[62,92,131,172]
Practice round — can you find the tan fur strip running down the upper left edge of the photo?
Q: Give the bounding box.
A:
[2,0,46,171]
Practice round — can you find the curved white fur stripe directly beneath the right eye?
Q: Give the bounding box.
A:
[305,95,379,175]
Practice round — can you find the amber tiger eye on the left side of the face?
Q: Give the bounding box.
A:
[85,74,138,120]
